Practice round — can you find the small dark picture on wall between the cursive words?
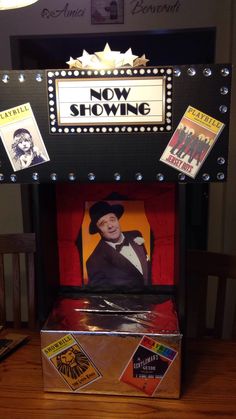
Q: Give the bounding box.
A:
[91,0,124,25]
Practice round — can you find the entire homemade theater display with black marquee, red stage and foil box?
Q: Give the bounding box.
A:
[0,60,232,398]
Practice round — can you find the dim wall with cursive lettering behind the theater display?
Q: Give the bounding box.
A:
[0,0,236,334]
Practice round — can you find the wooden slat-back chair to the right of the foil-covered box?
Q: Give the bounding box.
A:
[187,250,236,339]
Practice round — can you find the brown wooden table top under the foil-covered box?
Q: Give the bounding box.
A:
[0,333,236,419]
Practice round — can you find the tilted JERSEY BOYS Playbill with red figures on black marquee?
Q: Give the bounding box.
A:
[160,106,224,178]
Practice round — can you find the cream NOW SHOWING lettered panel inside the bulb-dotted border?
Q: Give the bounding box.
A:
[57,78,165,125]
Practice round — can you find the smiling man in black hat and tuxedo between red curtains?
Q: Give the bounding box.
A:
[86,201,150,291]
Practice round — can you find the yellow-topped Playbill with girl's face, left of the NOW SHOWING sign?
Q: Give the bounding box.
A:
[0,103,50,172]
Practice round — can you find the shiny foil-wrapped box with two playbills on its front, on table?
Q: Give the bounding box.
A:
[41,294,181,398]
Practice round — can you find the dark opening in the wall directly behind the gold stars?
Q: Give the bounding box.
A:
[11,28,215,70]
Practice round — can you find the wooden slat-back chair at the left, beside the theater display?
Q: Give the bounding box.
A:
[0,233,36,329]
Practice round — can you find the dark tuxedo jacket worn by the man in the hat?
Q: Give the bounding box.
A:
[86,231,150,291]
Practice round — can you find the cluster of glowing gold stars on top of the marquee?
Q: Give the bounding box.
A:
[66,44,149,69]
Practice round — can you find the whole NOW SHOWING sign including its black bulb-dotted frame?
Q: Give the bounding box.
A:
[49,69,172,133]
